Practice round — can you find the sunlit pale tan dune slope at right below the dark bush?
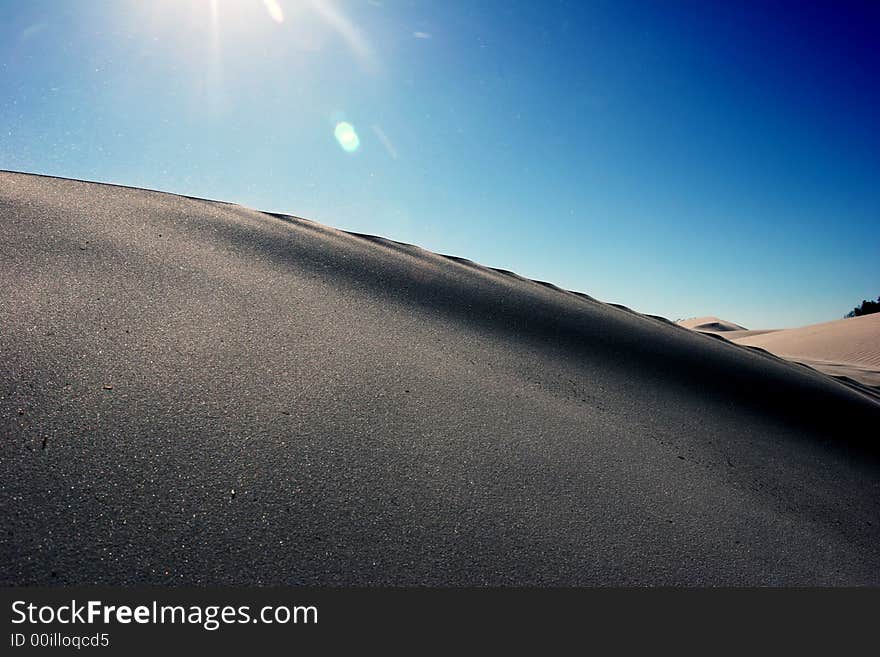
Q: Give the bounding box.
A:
[725,314,880,387]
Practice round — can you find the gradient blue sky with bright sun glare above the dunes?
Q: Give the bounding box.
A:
[0,0,880,327]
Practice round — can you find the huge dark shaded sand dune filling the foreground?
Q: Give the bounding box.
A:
[0,173,880,586]
